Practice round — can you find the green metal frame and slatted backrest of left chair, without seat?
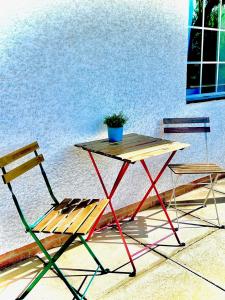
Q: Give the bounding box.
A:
[0,142,109,300]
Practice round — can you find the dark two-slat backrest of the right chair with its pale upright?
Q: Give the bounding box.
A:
[163,117,210,162]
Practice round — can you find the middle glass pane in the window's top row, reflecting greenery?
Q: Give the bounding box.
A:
[204,0,220,28]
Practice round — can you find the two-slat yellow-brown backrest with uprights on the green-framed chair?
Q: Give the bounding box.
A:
[0,142,59,229]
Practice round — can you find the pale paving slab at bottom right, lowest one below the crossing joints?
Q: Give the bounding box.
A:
[101,261,225,300]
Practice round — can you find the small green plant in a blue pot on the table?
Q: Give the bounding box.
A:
[104,112,128,143]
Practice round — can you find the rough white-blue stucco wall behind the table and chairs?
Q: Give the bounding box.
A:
[0,0,225,253]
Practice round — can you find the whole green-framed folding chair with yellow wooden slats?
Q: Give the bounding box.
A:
[0,142,109,300]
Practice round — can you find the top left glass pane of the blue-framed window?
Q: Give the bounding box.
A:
[188,0,203,27]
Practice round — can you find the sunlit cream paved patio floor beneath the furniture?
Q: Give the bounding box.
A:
[0,180,225,300]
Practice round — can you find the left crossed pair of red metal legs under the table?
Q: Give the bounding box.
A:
[87,151,136,277]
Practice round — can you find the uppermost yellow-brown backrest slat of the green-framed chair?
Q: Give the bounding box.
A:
[0,142,39,168]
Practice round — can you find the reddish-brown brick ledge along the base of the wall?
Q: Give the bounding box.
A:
[0,175,222,269]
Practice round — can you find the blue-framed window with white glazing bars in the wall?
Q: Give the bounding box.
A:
[187,0,225,103]
